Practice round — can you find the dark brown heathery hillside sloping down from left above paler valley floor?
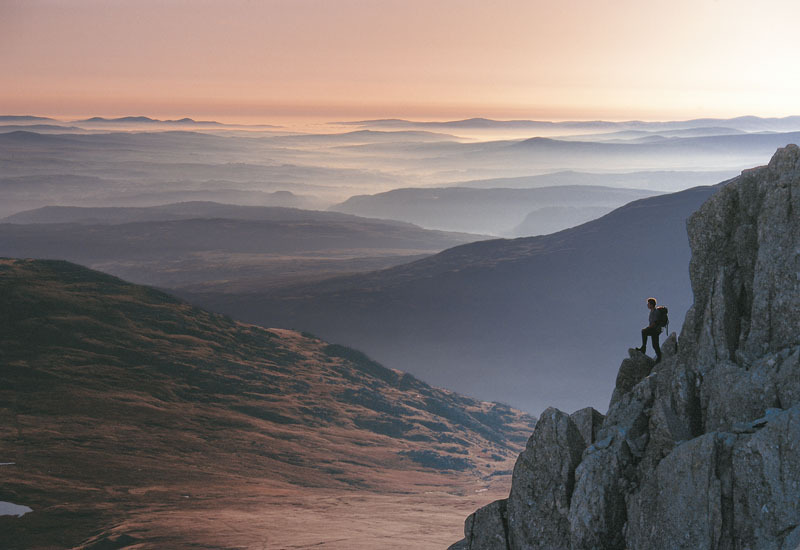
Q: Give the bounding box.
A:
[0,259,533,548]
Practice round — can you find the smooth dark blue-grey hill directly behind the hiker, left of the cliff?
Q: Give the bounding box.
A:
[185,179,718,412]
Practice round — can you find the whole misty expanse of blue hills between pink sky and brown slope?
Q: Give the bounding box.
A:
[0,116,800,413]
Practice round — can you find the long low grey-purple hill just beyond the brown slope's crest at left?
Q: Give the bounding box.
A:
[0,202,488,292]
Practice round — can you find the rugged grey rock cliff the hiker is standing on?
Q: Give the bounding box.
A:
[451,145,800,550]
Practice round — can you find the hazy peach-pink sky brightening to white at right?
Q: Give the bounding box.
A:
[0,0,800,122]
